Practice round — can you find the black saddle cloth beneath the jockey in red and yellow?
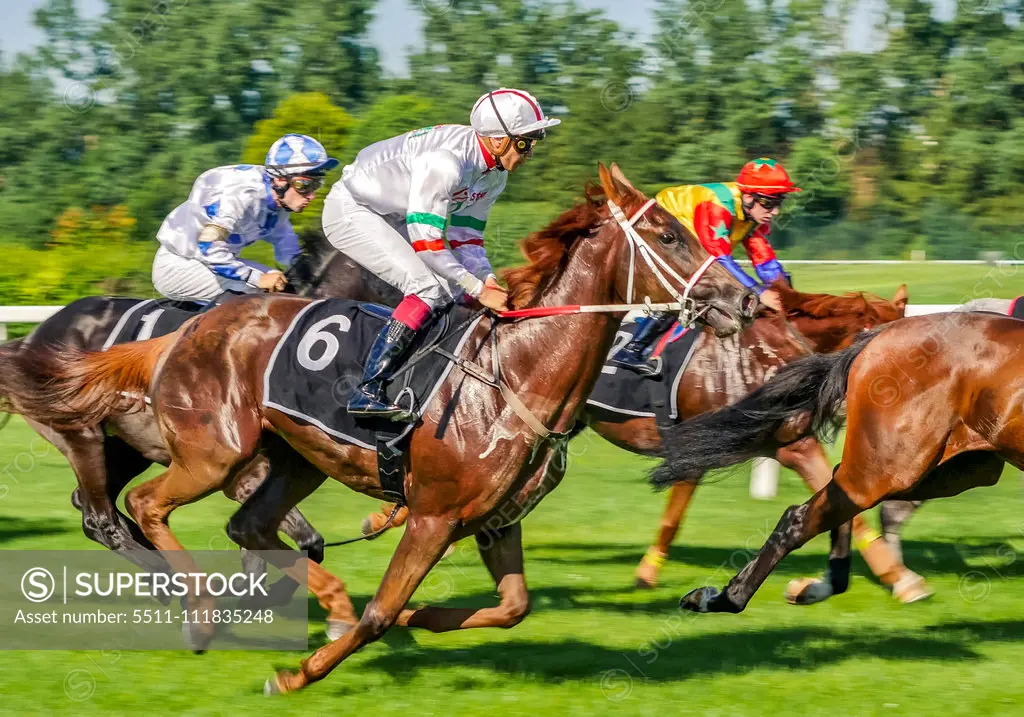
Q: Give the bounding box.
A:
[587,323,701,425]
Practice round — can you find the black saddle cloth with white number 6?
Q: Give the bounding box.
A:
[263,299,481,449]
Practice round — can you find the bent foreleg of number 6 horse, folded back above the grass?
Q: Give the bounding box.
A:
[398,523,529,632]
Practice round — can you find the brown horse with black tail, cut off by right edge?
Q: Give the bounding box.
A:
[653,313,1024,613]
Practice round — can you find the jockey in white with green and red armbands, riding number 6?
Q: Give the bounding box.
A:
[324,88,561,422]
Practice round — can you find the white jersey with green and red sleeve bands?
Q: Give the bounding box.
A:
[342,125,507,296]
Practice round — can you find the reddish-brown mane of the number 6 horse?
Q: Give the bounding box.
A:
[502,184,605,308]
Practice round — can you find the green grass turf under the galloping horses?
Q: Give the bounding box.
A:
[0,419,1024,717]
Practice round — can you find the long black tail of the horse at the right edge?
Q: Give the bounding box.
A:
[651,330,879,488]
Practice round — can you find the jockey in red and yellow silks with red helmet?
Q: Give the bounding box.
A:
[611,158,800,375]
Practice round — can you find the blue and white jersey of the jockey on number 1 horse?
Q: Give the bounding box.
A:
[157,164,300,287]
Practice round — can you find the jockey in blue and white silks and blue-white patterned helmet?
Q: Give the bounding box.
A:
[153,134,339,301]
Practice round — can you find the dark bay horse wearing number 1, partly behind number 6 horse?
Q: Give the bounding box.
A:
[0,231,400,628]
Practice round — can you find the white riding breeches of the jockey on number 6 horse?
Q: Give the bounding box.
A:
[324,181,448,308]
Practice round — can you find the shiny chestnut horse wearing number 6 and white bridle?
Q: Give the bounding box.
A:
[0,165,757,691]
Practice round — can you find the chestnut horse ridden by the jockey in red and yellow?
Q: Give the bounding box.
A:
[362,283,931,604]
